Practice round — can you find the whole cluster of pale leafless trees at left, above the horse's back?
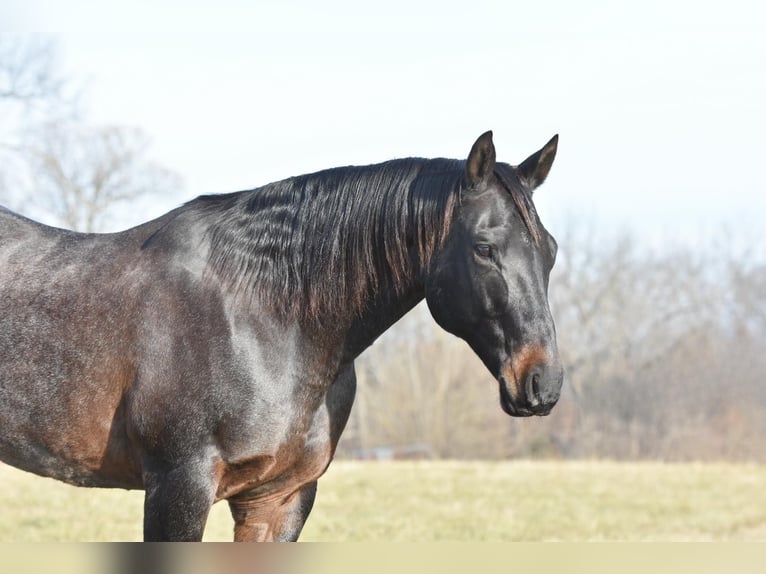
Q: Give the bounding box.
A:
[0,37,180,231]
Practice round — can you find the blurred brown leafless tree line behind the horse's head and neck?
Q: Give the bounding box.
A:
[339,220,766,461]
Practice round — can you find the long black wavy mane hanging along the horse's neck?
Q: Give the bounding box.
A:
[192,159,464,321]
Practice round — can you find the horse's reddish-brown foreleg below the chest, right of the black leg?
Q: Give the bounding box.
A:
[228,482,317,542]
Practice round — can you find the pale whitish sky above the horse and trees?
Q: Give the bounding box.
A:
[0,0,766,252]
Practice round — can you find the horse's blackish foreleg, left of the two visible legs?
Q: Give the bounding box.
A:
[144,462,216,542]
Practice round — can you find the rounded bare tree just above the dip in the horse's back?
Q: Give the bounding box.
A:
[23,123,180,232]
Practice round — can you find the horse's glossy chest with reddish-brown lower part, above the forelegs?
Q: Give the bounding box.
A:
[208,346,355,499]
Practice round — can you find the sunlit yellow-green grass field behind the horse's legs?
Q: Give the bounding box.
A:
[0,461,766,542]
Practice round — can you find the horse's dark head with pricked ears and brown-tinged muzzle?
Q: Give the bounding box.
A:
[425,132,563,416]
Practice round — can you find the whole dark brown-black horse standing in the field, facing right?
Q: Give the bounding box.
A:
[0,132,563,540]
